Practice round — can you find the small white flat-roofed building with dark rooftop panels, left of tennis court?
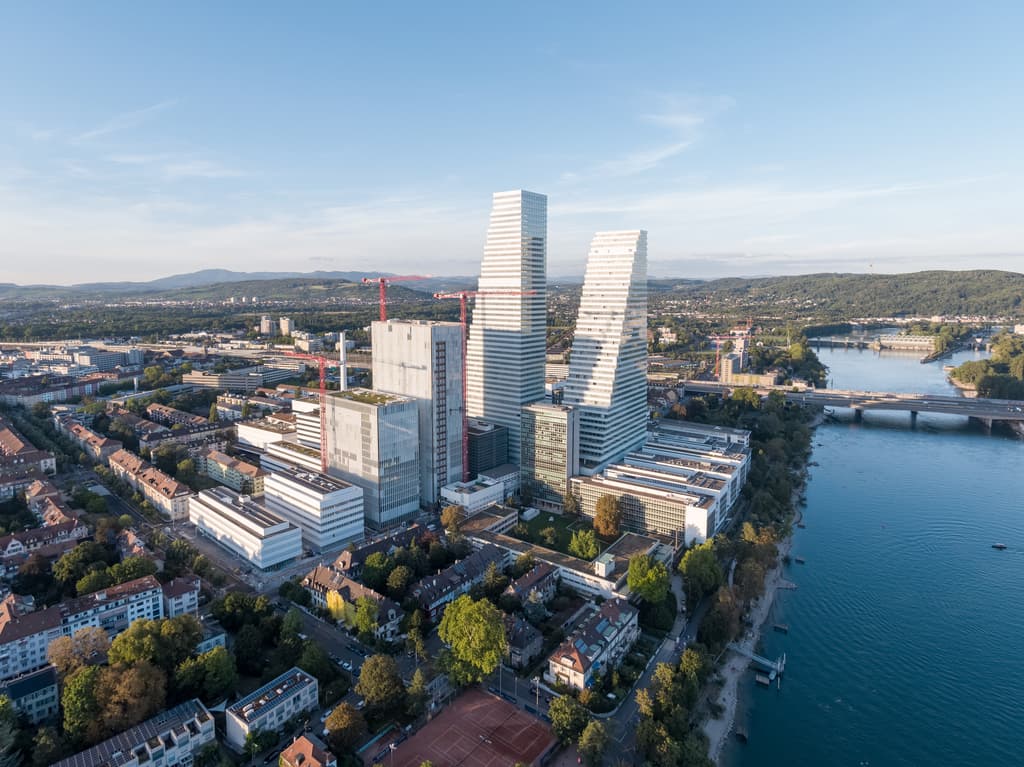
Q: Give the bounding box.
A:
[224,668,319,752]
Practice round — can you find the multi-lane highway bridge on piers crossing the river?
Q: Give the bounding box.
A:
[683,381,1024,426]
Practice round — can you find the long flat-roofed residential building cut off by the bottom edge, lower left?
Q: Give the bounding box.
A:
[53,698,217,767]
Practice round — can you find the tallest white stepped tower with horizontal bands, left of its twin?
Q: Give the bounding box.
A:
[466,189,548,464]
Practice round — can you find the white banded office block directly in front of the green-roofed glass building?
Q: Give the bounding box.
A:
[263,460,364,551]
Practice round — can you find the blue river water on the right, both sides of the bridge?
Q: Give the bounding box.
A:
[723,349,1024,767]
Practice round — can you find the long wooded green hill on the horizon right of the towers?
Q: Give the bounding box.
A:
[651,269,1024,319]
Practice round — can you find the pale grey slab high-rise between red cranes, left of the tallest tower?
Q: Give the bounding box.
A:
[373,319,464,505]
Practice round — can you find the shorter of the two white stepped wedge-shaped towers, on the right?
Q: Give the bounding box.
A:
[563,230,647,474]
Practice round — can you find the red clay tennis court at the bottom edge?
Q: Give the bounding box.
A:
[366,689,555,767]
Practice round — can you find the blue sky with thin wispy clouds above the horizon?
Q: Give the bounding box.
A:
[0,0,1024,284]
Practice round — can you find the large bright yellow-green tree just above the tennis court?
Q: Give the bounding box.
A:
[437,594,508,684]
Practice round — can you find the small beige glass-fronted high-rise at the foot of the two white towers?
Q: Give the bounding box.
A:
[520,402,580,506]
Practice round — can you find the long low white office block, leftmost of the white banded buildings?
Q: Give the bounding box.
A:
[188,487,302,570]
